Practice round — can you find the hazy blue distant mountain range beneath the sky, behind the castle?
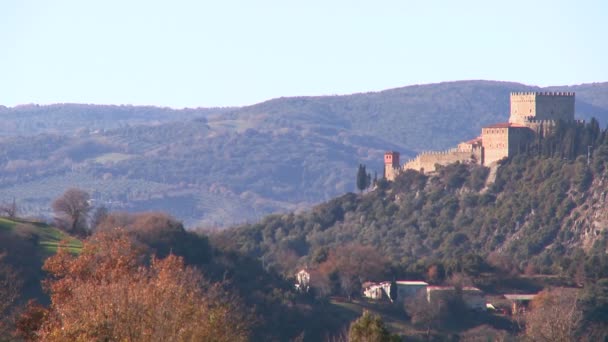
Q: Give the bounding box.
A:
[0,81,608,226]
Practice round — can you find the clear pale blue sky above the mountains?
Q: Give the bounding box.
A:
[0,0,608,108]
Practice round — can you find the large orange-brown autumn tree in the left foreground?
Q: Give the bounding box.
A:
[37,229,250,341]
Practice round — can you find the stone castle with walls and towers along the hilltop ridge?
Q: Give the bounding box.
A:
[384,92,574,180]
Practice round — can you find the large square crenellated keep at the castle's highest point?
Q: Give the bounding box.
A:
[509,92,574,125]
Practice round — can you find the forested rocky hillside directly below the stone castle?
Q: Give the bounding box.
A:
[221,121,608,282]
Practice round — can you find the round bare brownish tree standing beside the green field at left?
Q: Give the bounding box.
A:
[53,188,91,235]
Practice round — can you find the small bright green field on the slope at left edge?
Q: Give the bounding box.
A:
[0,217,82,256]
